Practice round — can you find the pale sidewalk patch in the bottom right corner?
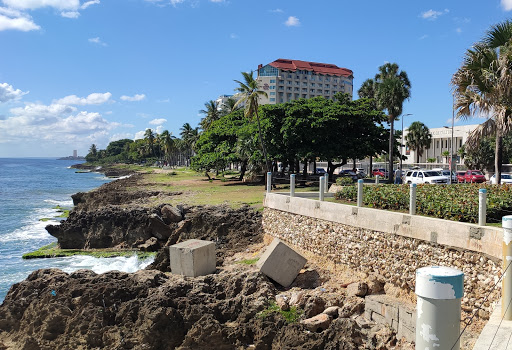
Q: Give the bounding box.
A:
[473,303,512,350]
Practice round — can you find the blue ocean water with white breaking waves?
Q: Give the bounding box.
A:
[0,158,153,302]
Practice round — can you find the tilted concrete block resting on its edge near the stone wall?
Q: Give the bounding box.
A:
[257,238,307,287]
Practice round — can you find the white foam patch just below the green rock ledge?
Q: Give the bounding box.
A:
[62,255,155,273]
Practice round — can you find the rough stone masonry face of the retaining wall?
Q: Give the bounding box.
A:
[263,208,501,318]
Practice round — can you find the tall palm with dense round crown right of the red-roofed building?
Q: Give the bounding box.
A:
[374,63,411,183]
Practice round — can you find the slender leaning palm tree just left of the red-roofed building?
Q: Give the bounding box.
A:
[235,71,271,172]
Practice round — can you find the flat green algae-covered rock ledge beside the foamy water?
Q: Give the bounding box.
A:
[23,242,155,259]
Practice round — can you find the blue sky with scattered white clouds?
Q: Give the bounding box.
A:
[0,0,512,157]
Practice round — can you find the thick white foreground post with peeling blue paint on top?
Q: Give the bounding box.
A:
[415,266,464,350]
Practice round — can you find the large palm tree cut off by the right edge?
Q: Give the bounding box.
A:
[452,20,512,184]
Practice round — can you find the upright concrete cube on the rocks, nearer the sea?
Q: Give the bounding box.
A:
[169,239,216,277]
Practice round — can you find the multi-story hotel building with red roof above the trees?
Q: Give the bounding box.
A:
[257,58,354,104]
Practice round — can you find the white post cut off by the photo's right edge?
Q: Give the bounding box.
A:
[501,215,512,321]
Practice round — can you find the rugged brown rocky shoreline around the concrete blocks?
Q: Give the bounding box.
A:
[0,168,412,350]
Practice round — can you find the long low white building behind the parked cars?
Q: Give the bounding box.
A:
[401,124,478,164]
